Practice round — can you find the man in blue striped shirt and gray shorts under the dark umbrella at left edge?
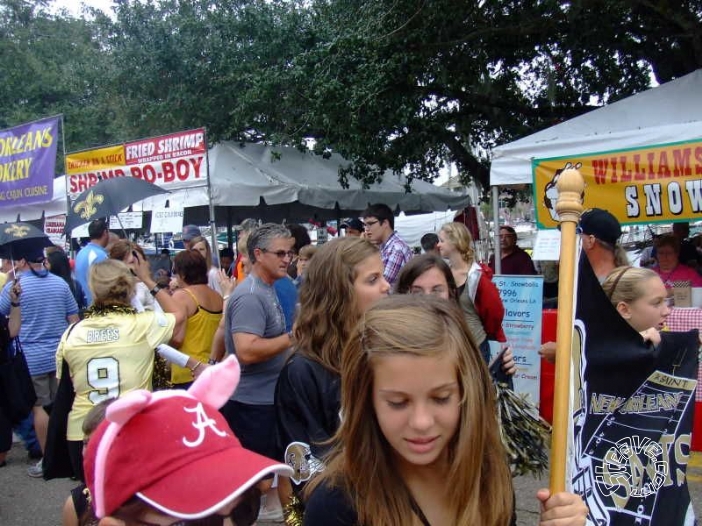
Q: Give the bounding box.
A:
[0,248,78,477]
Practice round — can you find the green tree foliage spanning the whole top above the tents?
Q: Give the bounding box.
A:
[0,0,702,195]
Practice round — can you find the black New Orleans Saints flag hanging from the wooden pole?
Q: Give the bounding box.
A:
[569,256,699,526]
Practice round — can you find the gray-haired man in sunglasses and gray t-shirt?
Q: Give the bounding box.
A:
[221,223,294,464]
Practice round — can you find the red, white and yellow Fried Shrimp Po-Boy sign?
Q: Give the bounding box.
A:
[66,128,207,198]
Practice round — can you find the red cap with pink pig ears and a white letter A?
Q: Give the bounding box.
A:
[83,356,292,519]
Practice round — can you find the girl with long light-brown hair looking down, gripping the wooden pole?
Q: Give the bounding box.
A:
[304,295,587,526]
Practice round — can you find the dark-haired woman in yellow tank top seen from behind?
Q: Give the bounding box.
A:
[171,250,223,389]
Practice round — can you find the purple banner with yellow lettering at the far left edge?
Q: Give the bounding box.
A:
[0,117,59,207]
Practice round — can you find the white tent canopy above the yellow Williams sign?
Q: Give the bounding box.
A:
[490,69,702,186]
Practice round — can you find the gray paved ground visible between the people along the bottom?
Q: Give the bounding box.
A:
[0,445,702,526]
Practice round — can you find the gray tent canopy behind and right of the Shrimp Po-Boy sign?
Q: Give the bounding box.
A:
[189,142,471,223]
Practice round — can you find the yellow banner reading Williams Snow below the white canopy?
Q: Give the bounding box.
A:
[532,139,702,228]
